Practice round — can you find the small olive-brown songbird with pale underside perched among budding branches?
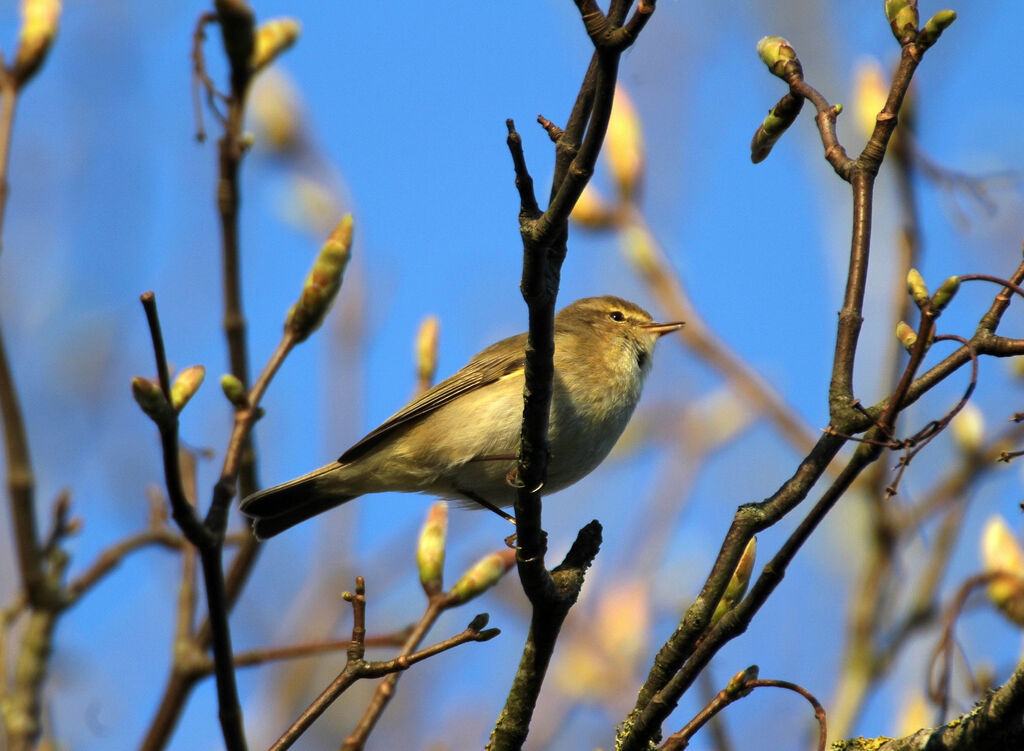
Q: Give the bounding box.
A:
[242,296,683,540]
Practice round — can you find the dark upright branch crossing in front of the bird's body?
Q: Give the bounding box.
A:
[487,7,654,751]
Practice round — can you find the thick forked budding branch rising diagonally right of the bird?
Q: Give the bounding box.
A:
[617,4,1017,749]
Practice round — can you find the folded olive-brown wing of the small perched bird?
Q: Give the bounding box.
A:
[338,334,526,463]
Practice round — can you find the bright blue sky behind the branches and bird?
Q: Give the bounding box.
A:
[0,0,1024,749]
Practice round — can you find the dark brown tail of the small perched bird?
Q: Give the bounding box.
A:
[240,462,355,540]
